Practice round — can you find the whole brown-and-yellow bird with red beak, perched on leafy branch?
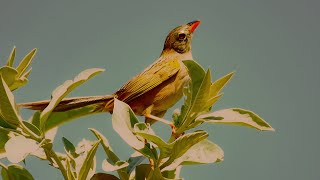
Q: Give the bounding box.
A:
[18,20,200,124]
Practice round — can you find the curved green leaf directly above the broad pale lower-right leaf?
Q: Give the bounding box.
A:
[160,131,209,169]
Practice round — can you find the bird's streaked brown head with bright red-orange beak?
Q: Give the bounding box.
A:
[163,20,200,54]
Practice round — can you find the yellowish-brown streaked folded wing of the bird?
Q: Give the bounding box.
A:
[115,58,180,102]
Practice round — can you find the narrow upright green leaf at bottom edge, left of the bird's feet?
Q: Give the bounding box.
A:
[78,140,100,180]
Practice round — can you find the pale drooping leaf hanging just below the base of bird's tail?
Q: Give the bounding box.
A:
[112,99,144,150]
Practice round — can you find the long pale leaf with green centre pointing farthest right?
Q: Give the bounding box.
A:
[197,108,274,131]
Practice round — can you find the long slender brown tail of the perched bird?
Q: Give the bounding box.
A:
[18,95,114,112]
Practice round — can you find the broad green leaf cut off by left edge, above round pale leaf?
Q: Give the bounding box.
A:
[0,75,20,125]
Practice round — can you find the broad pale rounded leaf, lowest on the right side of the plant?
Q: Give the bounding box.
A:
[163,139,224,171]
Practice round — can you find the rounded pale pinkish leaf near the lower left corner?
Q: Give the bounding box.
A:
[4,136,39,163]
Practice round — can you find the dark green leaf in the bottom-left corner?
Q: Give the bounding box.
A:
[1,164,34,180]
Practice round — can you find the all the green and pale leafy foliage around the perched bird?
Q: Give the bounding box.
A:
[0,48,274,180]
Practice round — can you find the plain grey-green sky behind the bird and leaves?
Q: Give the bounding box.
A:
[0,0,320,180]
